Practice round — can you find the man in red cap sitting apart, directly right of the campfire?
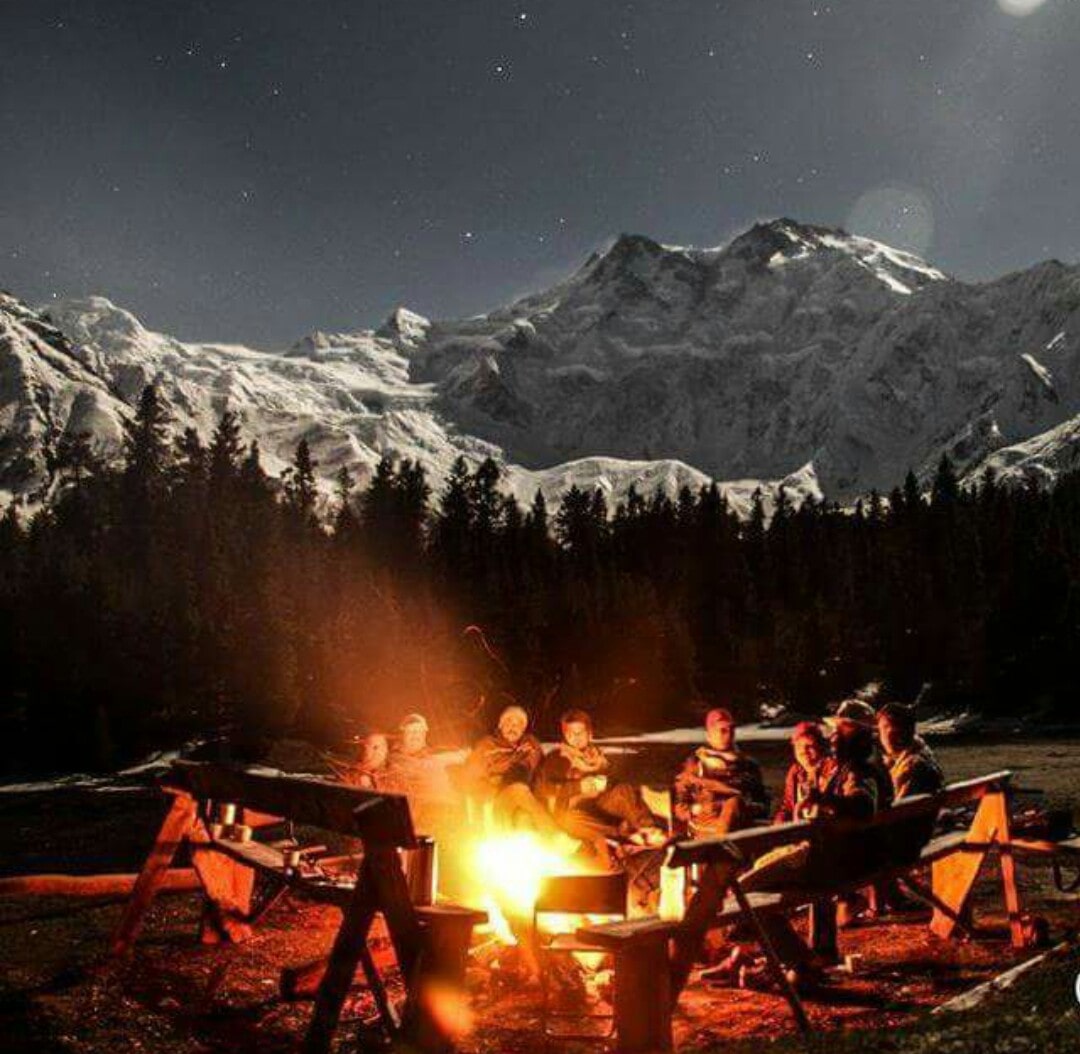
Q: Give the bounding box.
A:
[672,707,769,837]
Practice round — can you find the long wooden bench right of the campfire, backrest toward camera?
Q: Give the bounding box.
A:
[578,772,1024,1054]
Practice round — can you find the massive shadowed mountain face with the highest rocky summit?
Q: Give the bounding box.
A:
[413,220,1080,500]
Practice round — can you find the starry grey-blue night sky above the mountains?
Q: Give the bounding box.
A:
[0,0,1080,347]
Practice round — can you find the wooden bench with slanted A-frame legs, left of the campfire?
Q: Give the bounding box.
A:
[111,761,486,1054]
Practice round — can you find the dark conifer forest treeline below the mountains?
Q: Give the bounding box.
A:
[0,388,1080,769]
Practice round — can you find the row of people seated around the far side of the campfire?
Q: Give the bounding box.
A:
[349,699,944,894]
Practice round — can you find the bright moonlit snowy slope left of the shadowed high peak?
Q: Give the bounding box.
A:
[35,297,498,490]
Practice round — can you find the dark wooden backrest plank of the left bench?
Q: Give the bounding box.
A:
[163,761,416,848]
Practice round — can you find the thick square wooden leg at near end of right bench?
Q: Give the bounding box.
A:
[615,937,674,1054]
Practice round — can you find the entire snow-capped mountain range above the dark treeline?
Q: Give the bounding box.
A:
[0,219,1080,508]
